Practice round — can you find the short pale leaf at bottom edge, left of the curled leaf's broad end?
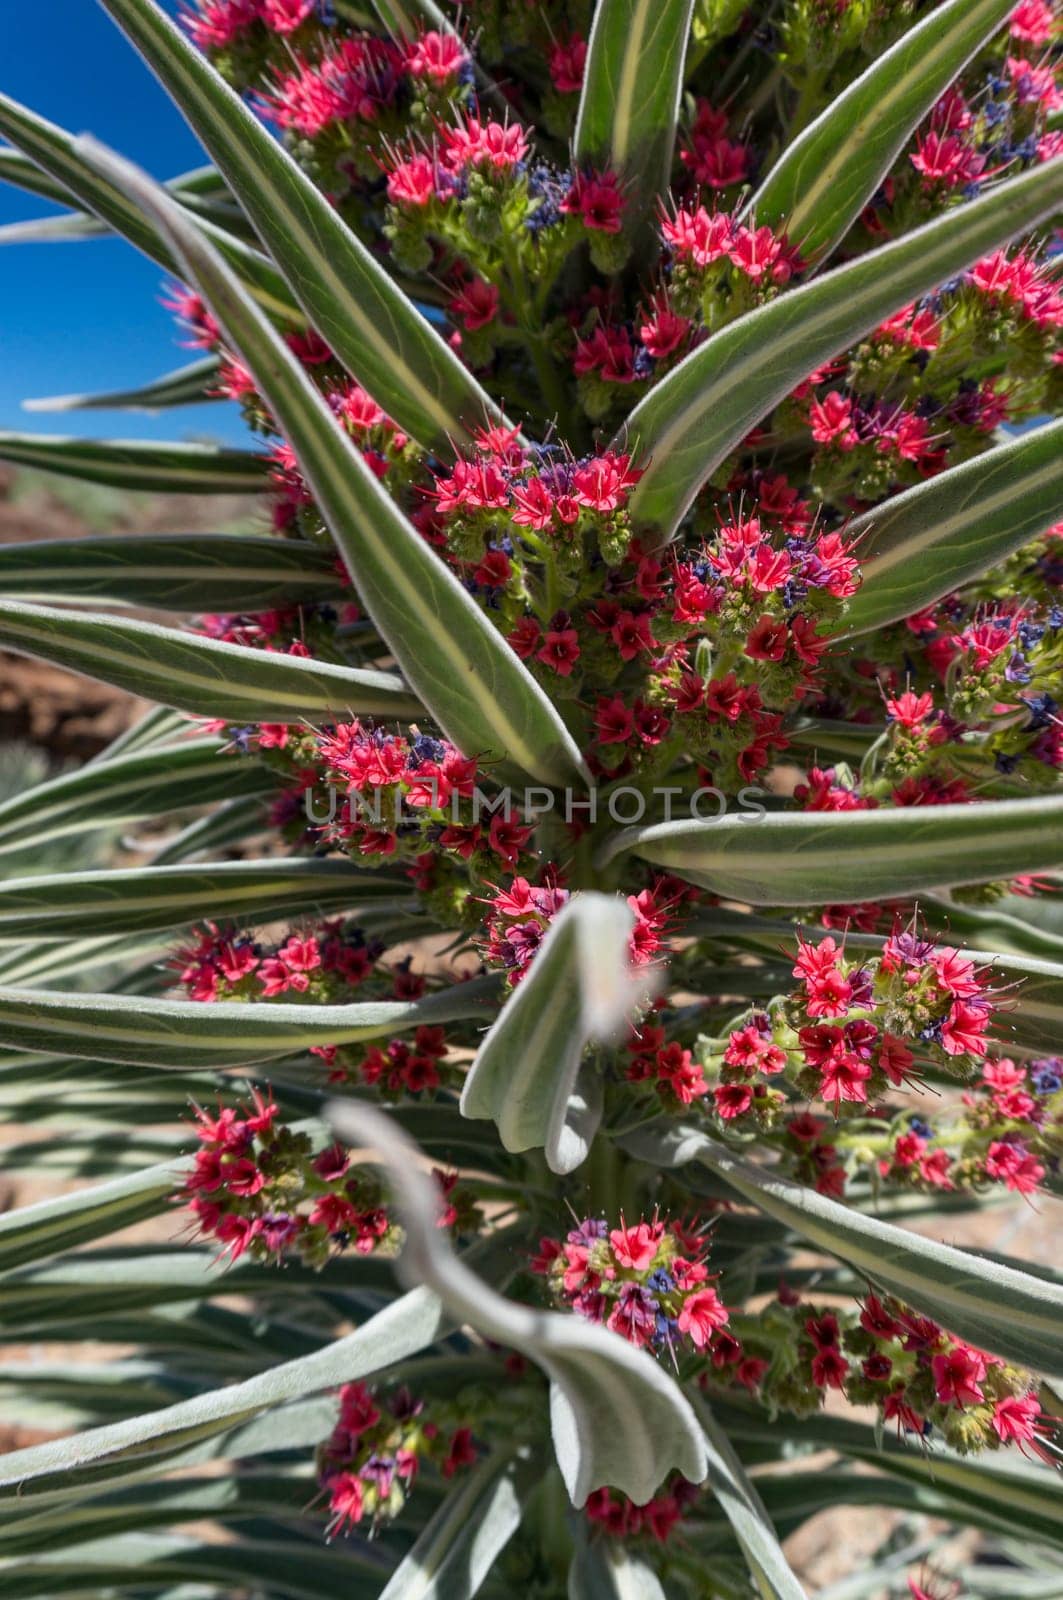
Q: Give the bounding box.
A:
[379,1450,536,1600]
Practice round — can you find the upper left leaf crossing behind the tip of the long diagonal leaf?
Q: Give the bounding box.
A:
[0,87,294,322]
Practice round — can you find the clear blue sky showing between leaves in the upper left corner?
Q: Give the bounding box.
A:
[0,0,247,442]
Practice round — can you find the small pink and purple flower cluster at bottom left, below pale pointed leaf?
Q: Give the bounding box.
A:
[317,1384,477,1534]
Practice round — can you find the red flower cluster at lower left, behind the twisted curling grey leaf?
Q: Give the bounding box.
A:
[179,1091,480,1267]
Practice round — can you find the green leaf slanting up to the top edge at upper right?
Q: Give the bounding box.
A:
[749,0,1012,262]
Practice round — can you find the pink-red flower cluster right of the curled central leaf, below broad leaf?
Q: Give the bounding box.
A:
[701,930,993,1126]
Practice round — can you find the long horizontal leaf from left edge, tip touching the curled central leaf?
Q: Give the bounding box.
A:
[0,979,496,1072]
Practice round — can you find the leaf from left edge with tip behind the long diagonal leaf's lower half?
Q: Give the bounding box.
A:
[0,600,423,723]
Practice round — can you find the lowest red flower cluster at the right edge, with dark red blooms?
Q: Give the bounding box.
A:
[706,1288,1049,1454]
